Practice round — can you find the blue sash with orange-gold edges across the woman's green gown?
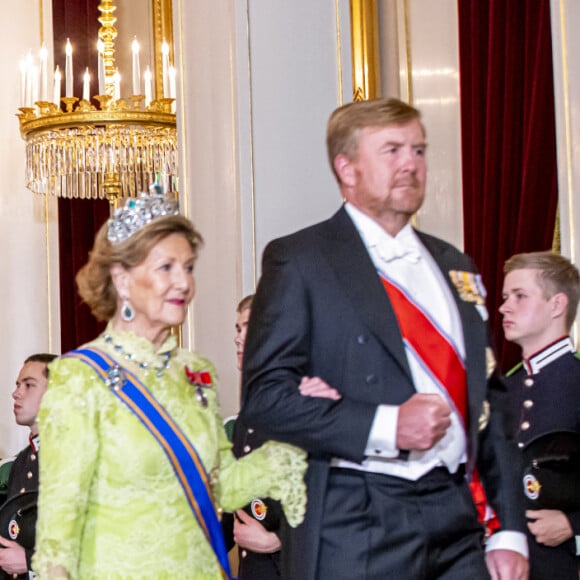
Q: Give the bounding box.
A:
[63,348,231,579]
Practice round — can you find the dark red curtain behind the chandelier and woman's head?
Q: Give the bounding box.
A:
[52,0,109,352]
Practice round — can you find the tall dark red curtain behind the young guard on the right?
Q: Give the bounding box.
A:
[458,0,558,370]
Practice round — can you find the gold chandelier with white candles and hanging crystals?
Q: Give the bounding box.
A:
[18,0,177,205]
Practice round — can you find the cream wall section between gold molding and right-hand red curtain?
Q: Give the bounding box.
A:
[397,0,463,248]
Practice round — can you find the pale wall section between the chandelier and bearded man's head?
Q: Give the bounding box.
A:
[174,0,352,414]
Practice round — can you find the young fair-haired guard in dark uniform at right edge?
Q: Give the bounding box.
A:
[499,252,580,580]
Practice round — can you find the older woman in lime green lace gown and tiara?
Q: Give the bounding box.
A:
[33,192,306,580]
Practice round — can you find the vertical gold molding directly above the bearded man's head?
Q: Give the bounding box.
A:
[350,0,381,101]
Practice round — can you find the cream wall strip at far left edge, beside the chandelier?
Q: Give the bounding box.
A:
[0,0,60,457]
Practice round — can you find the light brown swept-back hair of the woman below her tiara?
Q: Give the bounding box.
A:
[76,215,203,320]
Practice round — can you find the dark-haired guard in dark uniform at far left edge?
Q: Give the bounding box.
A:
[0,353,56,579]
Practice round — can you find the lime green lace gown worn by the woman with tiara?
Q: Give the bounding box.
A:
[33,328,306,580]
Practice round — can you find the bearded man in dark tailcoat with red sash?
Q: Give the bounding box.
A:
[241,99,527,580]
